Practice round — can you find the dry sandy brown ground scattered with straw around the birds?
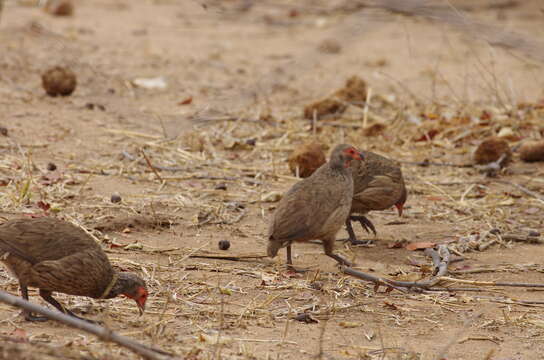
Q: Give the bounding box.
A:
[0,0,544,360]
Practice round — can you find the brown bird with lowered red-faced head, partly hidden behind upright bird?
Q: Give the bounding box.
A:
[346,151,407,244]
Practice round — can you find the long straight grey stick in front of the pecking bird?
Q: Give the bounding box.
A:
[0,290,174,360]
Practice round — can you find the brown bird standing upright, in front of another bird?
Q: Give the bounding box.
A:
[268,144,364,266]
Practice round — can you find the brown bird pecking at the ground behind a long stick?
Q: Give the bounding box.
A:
[0,217,148,321]
